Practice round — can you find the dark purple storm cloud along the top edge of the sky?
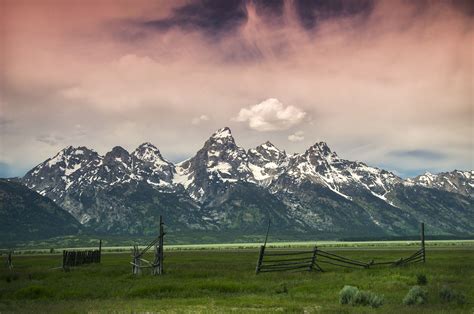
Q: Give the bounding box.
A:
[141,0,374,35]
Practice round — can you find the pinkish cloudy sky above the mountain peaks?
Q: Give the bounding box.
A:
[0,0,474,177]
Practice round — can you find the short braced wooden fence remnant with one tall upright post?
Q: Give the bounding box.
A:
[130,216,166,275]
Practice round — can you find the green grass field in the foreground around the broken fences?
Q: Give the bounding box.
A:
[0,246,474,313]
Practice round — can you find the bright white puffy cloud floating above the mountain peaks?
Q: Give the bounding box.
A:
[235,98,306,132]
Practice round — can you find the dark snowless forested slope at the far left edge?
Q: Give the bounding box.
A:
[0,179,81,243]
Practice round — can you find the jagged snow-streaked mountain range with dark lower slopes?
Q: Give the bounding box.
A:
[12,128,474,241]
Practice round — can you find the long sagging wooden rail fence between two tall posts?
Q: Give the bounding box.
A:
[255,221,426,274]
